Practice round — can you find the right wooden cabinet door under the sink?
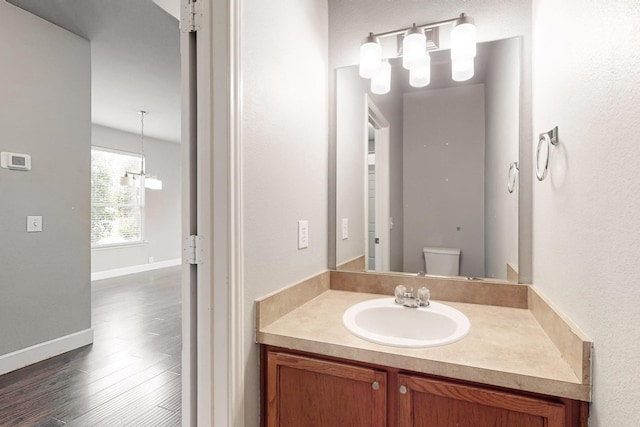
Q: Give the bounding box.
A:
[395,374,565,427]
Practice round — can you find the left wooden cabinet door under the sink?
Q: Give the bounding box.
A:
[266,352,387,427]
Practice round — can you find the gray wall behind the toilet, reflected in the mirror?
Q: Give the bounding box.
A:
[403,85,485,277]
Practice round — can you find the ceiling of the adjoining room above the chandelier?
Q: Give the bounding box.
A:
[8,0,181,142]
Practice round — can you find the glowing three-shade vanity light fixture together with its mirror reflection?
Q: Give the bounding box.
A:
[360,13,476,94]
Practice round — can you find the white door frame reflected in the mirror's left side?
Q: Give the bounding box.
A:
[365,95,391,271]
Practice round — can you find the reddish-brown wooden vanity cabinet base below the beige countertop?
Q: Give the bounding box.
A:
[261,346,588,427]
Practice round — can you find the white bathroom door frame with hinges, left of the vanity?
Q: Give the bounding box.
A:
[180,0,245,427]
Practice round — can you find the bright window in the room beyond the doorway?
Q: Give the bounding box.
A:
[91,147,144,248]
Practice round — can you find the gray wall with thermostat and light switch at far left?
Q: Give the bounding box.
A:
[0,2,91,354]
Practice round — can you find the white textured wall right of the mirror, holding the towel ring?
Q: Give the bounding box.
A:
[533,0,640,427]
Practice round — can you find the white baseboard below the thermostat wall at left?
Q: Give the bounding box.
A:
[0,328,93,375]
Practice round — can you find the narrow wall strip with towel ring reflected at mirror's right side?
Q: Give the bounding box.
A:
[484,38,520,279]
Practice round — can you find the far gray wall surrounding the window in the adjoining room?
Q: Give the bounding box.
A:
[91,123,181,273]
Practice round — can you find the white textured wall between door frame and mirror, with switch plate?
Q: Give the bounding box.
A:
[241,0,328,426]
